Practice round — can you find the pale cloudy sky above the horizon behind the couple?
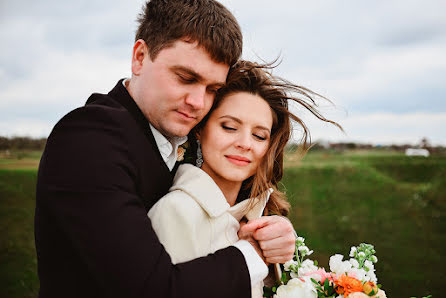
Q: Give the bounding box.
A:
[0,0,446,146]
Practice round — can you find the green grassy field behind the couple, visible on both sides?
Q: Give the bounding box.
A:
[0,152,446,298]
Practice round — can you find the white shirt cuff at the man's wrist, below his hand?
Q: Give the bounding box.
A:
[233,240,268,287]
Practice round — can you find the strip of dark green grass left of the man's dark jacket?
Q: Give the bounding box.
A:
[0,170,39,297]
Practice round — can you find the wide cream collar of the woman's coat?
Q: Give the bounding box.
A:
[169,164,272,221]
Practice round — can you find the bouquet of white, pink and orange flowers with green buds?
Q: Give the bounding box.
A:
[264,237,386,298]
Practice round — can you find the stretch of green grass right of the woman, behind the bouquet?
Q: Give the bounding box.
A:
[283,153,446,297]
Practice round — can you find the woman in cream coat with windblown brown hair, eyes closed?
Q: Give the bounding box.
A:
[148,61,339,297]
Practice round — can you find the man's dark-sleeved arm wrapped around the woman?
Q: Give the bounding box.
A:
[36,108,250,297]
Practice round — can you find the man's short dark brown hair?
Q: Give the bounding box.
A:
[135,0,243,66]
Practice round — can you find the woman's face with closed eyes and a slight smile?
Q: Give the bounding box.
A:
[198,92,273,189]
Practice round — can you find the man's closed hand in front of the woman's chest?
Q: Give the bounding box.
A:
[238,216,296,263]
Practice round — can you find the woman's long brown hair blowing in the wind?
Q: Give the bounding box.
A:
[192,61,342,215]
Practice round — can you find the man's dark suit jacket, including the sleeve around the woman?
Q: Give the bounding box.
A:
[35,81,251,298]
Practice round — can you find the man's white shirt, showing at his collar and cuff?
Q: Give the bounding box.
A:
[122,79,268,286]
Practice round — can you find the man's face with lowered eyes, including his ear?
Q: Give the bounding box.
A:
[129,40,229,137]
